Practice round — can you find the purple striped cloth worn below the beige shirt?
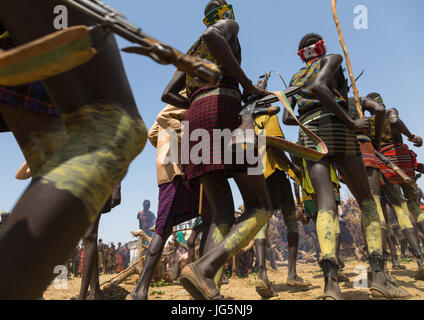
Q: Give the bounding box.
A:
[155,176,202,235]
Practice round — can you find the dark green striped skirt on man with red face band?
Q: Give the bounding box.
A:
[299,108,361,157]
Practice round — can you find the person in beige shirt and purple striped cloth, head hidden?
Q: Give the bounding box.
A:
[126,99,209,300]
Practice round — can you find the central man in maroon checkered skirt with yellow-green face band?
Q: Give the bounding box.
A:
[159,0,272,299]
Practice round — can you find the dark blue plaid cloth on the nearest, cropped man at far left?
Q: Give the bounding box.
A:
[0,34,59,132]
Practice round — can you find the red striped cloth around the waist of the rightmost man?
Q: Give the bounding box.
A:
[378,144,418,184]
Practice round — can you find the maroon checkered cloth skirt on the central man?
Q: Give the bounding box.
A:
[182,87,248,181]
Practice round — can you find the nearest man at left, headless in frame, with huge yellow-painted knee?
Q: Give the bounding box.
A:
[0,0,147,299]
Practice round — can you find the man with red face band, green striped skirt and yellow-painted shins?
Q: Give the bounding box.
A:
[284,34,409,300]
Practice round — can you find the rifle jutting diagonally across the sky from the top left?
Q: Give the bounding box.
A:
[61,0,221,85]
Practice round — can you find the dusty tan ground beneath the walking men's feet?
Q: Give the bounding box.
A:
[44,261,424,300]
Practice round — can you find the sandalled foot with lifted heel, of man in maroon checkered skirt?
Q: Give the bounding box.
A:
[180,263,222,300]
